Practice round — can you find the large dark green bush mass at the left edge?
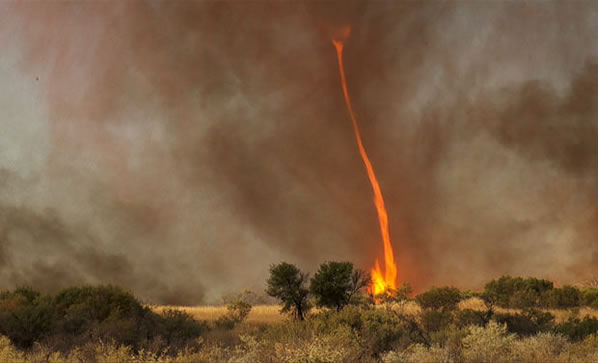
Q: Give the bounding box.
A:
[0,286,207,351]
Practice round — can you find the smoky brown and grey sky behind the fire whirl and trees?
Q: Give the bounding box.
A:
[0,1,598,304]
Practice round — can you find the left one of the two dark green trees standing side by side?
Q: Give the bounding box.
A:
[266,262,311,320]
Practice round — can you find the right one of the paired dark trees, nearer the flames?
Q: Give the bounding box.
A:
[311,262,370,311]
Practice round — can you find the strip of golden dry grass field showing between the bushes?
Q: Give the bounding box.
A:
[152,298,598,324]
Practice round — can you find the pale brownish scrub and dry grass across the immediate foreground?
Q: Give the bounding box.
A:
[0,306,598,363]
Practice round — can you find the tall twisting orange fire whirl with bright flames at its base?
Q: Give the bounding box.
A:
[332,32,397,295]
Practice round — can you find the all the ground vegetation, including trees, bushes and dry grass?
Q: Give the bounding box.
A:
[0,270,598,362]
